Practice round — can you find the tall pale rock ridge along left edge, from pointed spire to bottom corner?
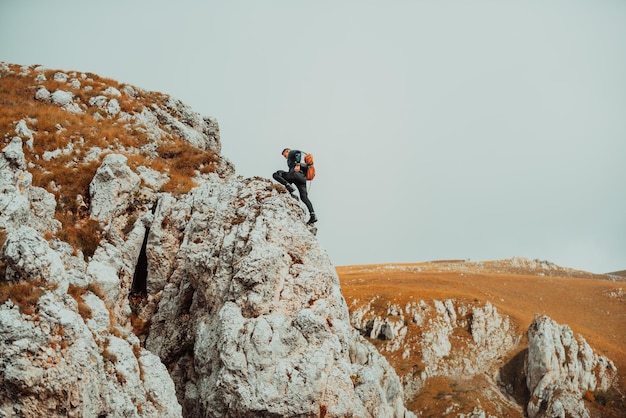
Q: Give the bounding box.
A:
[0,138,181,417]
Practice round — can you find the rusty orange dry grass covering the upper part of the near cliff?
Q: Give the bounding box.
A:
[0,65,219,257]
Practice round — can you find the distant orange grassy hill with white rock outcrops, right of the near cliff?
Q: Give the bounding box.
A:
[337,258,626,417]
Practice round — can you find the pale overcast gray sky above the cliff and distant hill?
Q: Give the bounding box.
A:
[0,0,626,273]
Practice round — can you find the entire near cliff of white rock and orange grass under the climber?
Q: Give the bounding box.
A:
[0,64,412,417]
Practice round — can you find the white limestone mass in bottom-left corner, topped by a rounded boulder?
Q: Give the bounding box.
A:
[0,232,181,417]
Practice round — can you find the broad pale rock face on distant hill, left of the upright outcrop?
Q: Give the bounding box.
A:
[351,297,524,417]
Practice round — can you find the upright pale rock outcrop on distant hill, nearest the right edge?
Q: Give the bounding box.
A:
[526,316,617,418]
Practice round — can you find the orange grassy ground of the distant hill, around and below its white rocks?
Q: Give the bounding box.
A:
[337,258,626,417]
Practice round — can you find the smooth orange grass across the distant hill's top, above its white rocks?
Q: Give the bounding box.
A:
[337,262,626,416]
